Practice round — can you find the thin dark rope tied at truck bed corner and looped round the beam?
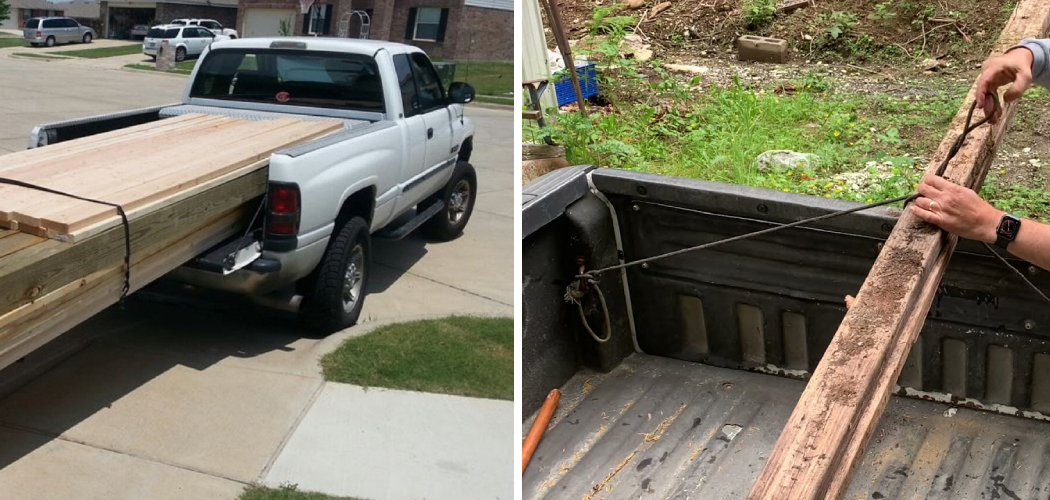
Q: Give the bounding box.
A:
[565,92,1050,342]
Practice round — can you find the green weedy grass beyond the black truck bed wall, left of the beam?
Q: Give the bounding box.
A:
[533,69,963,202]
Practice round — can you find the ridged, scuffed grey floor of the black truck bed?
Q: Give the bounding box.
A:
[522,354,1050,500]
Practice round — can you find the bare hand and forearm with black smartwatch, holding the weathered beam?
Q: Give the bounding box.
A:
[911,175,1050,269]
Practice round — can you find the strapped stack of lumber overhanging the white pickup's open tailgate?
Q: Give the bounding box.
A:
[0,114,343,368]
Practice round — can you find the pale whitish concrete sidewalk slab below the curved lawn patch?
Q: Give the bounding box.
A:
[264,382,515,500]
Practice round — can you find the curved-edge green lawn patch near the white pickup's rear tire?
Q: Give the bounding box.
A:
[321,316,515,400]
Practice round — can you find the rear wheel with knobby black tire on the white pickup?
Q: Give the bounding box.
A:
[299,217,372,335]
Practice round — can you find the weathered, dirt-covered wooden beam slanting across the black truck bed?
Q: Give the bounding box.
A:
[749,0,1050,500]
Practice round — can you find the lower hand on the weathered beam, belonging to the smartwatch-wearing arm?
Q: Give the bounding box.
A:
[911,175,1004,244]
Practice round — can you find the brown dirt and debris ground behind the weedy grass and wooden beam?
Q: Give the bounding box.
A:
[548,0,1050,195]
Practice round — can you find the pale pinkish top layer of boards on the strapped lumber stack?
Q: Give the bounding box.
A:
[0,114,343,242]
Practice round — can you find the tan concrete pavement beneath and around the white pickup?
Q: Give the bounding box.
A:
[0,50,515,500]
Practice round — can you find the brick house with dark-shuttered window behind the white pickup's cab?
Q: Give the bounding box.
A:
[236,0,515,61]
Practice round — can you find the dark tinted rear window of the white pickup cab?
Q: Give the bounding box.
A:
[190,48,385,112]
